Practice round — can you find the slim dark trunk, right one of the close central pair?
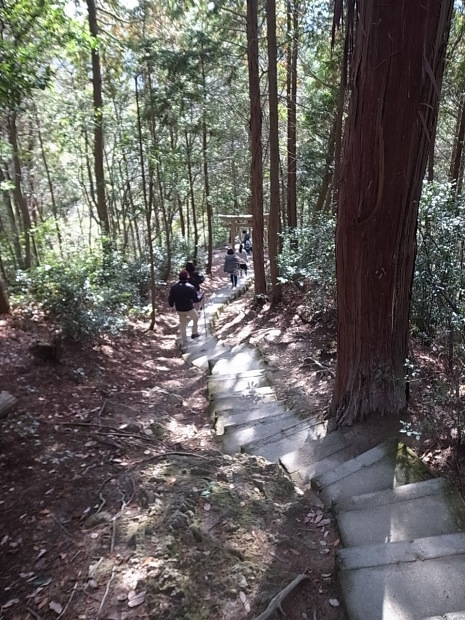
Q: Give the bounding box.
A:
[266,0,282,303]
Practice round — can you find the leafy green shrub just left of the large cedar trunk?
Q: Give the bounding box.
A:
[278,213,336,307]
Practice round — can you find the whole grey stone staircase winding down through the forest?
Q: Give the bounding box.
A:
[185,281,465,620]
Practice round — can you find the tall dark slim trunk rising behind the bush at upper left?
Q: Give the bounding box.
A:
[87,0,110,239]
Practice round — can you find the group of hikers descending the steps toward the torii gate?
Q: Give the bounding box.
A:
[168,230,252,348]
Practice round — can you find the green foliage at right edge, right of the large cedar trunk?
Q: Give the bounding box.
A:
[411,183,465,337]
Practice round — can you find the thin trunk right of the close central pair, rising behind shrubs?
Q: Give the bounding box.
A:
[287,0,298,228]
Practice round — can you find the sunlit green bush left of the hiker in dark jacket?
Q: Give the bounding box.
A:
[15,252,148,340]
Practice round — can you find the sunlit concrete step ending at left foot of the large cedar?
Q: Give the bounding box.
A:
[242,414,326,463]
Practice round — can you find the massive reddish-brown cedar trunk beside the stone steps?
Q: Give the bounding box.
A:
[331,0,453,424]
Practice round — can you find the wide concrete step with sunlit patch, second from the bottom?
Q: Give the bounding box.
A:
[334,478,465,547]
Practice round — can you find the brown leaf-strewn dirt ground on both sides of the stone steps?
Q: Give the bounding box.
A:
[0,256,461,620]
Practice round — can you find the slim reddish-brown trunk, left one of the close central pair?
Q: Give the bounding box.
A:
[247,0,266,294]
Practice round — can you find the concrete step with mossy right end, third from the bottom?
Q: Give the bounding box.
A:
[312,440,433,504]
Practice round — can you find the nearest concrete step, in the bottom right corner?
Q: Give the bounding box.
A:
[338,532,465,620]
